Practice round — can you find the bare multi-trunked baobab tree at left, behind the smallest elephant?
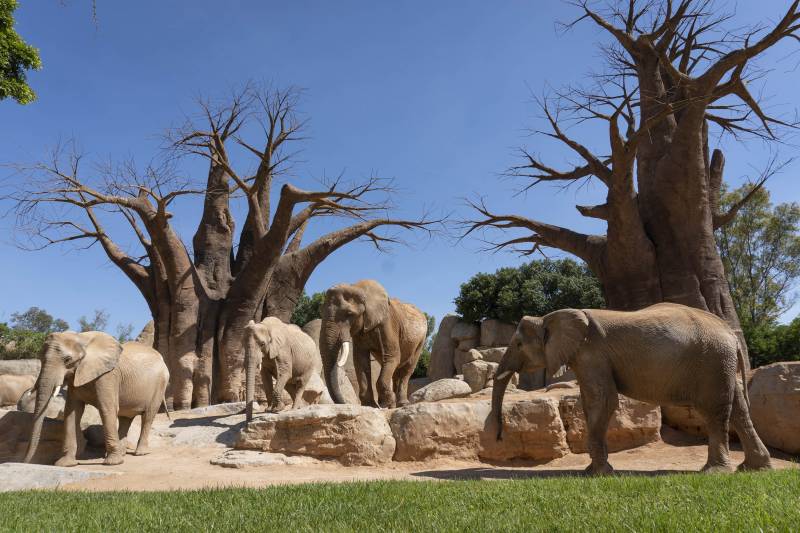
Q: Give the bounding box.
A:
[11,86,432,408]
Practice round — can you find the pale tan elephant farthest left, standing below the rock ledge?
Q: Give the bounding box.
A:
[24,331,169,466]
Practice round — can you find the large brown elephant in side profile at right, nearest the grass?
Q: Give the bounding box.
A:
[489,303,771,474]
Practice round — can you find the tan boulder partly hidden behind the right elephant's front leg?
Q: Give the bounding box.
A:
[547,388,661,453]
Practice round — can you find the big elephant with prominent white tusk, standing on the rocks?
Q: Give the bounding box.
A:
[319,280,428,408]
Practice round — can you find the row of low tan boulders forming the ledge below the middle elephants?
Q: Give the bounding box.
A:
[234,389,661,465]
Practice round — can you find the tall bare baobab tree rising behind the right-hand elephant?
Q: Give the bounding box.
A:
[466,0,800,366]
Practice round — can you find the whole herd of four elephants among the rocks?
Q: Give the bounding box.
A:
[3,280,771,474]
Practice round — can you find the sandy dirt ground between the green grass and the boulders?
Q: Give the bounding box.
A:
[54,428,798,491]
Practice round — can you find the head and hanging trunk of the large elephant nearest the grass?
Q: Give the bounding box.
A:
[490,309,589,440]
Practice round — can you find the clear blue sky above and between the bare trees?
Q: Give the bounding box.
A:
[0,0,800,329]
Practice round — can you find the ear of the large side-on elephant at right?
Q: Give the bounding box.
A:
[543,309,589,378]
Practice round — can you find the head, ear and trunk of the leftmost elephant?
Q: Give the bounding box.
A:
[24,331,122,463]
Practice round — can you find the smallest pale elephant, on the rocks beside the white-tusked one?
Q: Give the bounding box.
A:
[244,317,322,421]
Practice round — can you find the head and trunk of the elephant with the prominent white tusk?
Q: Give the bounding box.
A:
[319,280,389,403]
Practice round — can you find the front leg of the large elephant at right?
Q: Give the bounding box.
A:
[580,372,619,475]
